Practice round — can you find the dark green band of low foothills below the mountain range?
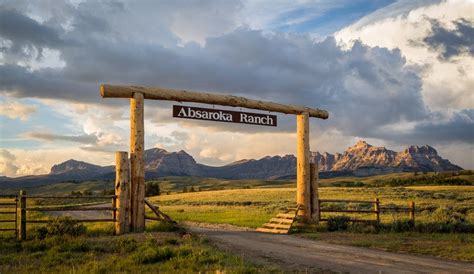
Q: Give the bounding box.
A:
[0,170,474,195]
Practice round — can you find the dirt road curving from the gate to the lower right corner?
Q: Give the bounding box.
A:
[187,223,474,273]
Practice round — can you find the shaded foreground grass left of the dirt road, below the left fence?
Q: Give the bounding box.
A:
[0,225,276,273]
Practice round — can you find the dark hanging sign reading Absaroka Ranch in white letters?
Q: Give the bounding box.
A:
[173,105,277,127]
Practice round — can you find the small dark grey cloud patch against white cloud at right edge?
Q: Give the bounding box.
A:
[423,19,474,60]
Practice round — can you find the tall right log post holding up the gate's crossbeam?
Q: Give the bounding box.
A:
[296,112,311,221]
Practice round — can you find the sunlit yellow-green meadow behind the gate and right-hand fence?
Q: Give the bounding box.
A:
[149,186,474,228]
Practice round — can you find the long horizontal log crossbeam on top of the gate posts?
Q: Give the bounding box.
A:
[100,85,329,119]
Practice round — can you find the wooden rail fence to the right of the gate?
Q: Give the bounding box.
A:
[318,198,415,223]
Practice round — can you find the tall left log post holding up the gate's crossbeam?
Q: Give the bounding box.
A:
[130,93,145,232]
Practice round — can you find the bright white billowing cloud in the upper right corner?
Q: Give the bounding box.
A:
[336,0,474,110]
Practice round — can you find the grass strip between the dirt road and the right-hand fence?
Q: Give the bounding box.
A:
[300,231,474,262]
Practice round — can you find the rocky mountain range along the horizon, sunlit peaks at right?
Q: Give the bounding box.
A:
[0,141,462,188]
